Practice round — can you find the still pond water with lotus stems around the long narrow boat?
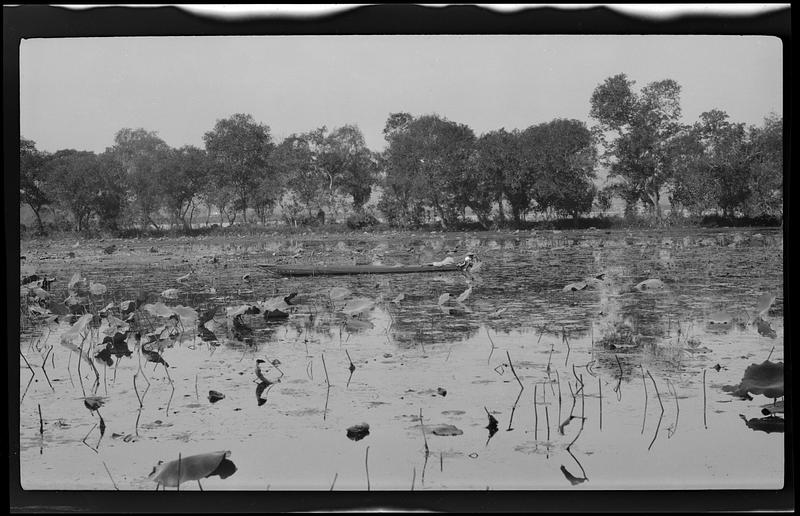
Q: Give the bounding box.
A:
[20,229,784,490]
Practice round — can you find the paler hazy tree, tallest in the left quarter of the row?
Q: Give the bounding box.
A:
[109,128,170,230]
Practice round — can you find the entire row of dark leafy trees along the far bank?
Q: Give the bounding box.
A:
[20,74,783,232]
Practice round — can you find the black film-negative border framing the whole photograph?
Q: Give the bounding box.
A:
[3,4,794,513]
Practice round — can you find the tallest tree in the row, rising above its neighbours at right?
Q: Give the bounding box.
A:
[590,74,681,218]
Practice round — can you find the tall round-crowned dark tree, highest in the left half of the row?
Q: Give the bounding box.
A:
[203,113,274,222]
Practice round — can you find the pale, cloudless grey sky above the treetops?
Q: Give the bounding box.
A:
[20,36,783,152]
